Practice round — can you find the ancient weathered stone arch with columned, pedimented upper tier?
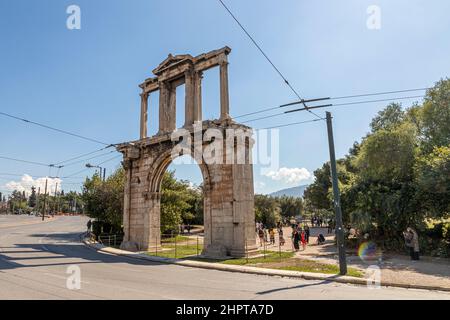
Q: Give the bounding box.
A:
[117,47,257,257]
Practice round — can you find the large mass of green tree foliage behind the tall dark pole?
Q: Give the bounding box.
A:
[305,79,450,251]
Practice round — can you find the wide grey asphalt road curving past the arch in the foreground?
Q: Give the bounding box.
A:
[0,216,450,300]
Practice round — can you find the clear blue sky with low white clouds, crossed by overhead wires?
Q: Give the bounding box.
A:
[0,0,450,193]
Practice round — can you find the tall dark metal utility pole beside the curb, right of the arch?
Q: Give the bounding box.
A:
[326,112,347,275]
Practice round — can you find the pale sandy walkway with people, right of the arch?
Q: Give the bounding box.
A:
[258,227,450,288]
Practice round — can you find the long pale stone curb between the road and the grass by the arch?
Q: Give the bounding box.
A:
[82,238,450,292]
